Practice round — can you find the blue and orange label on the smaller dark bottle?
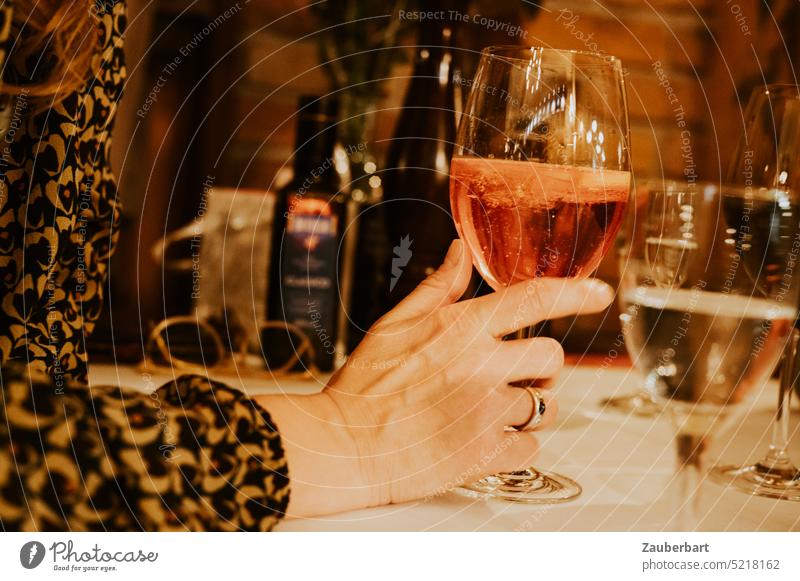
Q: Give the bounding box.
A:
[281,194,339,370]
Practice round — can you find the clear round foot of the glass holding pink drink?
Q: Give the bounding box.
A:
[464,468,583,504]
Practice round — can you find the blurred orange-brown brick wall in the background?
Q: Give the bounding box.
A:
[212,0,716,186]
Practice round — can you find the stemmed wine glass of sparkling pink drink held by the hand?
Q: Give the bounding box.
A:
[450,46,631,503]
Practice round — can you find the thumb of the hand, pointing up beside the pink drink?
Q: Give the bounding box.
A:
[389,238,472,319]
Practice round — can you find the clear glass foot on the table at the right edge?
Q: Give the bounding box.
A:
[711,462,800,502]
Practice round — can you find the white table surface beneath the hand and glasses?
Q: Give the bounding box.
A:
[91,365,800,531]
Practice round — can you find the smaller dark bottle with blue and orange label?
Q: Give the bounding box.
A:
[264,96,344,371]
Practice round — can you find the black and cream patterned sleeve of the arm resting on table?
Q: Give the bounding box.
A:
[0,366,289,531]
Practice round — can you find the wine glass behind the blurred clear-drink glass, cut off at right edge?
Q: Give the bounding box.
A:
[711,85,800,501]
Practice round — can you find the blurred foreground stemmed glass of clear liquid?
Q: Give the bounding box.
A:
[619,176,800,530]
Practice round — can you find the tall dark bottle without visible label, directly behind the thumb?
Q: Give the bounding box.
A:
[383,1,456,309]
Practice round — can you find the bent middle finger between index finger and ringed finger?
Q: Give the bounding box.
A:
[483,337,564,383]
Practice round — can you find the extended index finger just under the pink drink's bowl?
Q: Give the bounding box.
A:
[466,278,614,337]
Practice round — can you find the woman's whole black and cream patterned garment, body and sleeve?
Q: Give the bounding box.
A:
[0,0,289,531]
